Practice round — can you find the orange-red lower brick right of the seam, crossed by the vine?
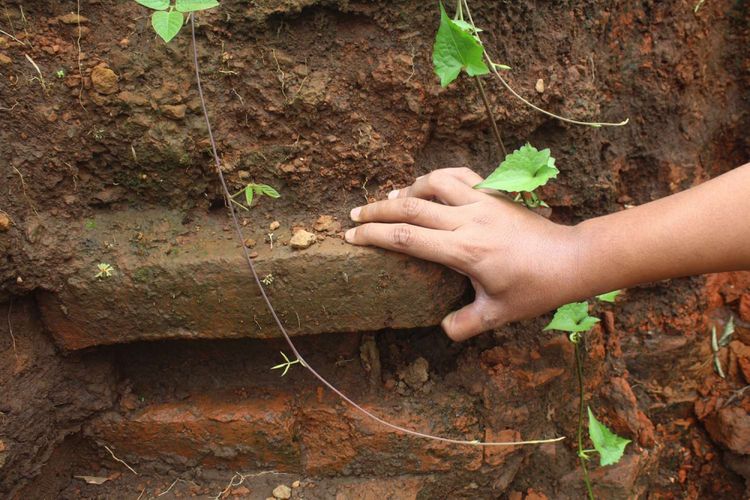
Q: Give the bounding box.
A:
[298,394,482,475]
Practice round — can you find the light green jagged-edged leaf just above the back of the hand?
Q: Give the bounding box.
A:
[474,144,560,192]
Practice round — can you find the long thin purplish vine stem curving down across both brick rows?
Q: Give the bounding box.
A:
[190,13,565,446]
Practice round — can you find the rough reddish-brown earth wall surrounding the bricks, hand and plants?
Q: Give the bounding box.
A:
[0,0,750,499]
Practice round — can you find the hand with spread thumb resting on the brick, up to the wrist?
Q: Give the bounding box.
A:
[346,168,579,341]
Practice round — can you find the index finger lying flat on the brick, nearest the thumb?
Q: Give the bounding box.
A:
[345,222,463,268]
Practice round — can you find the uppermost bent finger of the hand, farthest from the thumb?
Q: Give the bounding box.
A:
[388,168,484,206]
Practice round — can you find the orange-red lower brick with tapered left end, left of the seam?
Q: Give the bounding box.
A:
[86,392,301,472]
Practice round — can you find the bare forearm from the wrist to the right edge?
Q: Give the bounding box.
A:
[575,164,750,297]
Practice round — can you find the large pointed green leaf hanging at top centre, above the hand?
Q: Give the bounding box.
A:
[432,3,490,87]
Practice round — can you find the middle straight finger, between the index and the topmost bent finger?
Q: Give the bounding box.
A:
[351,198,463,231]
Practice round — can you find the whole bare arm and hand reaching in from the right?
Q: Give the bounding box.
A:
[346,163,750,341]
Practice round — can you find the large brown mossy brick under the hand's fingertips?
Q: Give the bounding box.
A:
[39,211,467,349]
